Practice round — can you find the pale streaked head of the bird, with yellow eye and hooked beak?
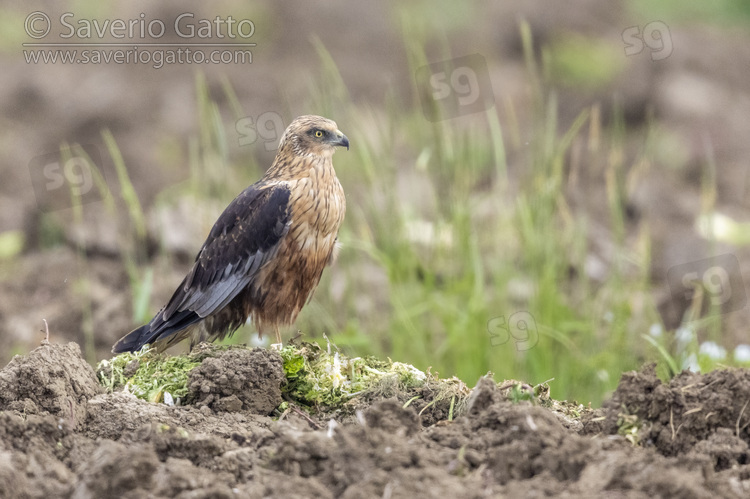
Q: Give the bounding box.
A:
[279,115,349,158]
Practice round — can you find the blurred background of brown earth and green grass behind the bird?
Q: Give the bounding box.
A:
[0,0,750,405]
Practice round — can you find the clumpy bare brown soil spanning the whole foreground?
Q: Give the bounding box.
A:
[0,343,750,498]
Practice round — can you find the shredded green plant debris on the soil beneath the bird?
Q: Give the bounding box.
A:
[96,343,469,419]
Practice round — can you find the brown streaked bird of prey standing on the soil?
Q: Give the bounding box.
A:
[112,116,349,353]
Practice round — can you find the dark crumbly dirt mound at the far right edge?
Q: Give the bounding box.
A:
[586,365,750,471]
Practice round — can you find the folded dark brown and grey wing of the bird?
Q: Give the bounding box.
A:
[112,183,291,353]
